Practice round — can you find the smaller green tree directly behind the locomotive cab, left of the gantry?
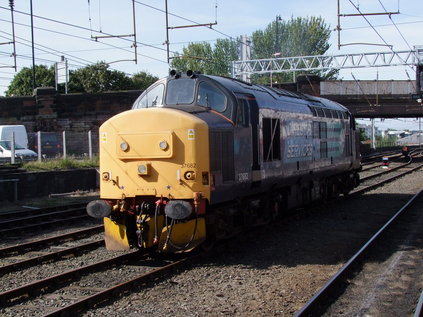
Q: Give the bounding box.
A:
[171,39,238,76]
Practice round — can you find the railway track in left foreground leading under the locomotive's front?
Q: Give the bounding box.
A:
[0,244,195,316]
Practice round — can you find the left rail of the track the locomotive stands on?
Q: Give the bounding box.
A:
[0,250,142,307]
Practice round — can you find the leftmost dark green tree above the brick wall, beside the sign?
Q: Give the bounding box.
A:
[6,65,54,97]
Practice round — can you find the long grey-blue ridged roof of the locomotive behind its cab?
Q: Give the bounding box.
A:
[205,75,348,111]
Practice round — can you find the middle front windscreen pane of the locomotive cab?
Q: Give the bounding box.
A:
[166,78,195,105]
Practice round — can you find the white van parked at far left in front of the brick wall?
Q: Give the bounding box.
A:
[0,125,37,161]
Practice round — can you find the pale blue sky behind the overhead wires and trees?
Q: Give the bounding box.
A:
[0,0,423,129]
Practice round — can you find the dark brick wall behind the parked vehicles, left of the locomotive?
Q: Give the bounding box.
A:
[0,88,141,132]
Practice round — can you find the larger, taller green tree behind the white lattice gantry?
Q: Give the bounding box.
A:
[252,17,338,83]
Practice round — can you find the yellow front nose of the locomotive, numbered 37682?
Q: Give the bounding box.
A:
[100,108,210,199]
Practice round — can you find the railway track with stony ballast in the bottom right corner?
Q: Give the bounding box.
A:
[295,186,423,317]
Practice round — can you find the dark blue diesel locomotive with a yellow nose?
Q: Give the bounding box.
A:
[87,71,361,252]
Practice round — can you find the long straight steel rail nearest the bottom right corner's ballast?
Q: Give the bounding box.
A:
[294,189,423,317]
